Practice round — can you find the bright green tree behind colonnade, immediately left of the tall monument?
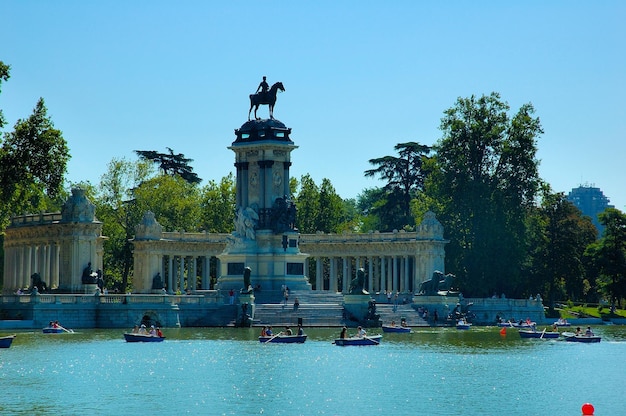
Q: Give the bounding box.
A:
[200,173,236,233]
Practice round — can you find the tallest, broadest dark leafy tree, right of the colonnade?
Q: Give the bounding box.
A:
[422,93,543,296]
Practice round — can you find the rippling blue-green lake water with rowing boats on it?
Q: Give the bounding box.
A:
[0,326,626,416]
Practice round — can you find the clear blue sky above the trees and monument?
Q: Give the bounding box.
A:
[0,0,626,211]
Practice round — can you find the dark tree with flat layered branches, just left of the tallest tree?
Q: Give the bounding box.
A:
[365,142,431,229]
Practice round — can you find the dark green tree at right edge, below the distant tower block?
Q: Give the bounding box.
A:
[588,208,626,307]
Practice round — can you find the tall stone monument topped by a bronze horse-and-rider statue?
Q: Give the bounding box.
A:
[218,79,311,290]
